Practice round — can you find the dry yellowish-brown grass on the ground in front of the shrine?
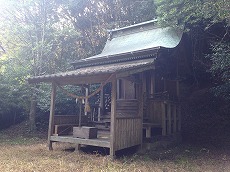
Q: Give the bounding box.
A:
[0,121,230,172]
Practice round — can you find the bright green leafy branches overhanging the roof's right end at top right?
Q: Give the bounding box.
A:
[155,0,230,27]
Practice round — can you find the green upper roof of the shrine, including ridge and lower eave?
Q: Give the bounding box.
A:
[73,20,183,68]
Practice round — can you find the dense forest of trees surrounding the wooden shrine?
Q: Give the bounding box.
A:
[0,0,230,144]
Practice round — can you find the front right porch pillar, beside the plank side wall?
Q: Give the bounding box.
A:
[110,77,117,159]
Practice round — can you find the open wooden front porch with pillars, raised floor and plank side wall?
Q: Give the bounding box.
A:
[48,71,146,156]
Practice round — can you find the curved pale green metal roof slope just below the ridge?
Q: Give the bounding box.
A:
[101,28,182,56]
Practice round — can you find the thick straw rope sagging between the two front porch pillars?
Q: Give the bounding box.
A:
[56,74,115,99]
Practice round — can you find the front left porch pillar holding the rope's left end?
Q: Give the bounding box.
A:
[48,83,57,150]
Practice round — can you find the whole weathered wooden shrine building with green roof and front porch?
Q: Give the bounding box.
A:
[28,21,190,156]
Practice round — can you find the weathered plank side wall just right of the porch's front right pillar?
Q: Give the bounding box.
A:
[115,99,142,150]
